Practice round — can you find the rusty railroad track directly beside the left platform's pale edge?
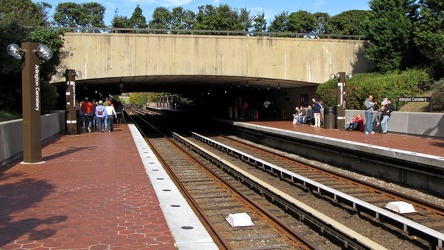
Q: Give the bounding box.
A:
[126,109,318,249]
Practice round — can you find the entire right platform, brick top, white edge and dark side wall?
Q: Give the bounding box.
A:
[232,120,444,197]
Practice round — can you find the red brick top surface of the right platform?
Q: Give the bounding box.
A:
[248,121,444,156]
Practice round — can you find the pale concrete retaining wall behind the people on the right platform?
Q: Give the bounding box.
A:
[345,110,444,138]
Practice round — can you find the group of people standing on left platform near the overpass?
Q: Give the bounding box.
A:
[77,97,123,132]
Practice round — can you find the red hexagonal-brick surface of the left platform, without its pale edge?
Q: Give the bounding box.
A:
[0,124,175,249]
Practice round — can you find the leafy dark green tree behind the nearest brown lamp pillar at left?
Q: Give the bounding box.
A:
[0,0,63,112]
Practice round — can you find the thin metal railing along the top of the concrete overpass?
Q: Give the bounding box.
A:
[51,27,365,40]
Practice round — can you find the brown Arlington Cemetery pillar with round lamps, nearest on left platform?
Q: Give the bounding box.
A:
[7,42,52,163]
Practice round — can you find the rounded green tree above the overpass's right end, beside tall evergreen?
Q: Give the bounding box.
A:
[330,10,369,36]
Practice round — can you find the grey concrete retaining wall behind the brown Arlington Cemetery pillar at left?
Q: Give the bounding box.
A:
[0,110,65,166]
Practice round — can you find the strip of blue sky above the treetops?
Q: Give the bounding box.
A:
[32,0,369,25]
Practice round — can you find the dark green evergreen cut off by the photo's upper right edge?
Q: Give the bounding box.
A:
[414,0,444,78]
